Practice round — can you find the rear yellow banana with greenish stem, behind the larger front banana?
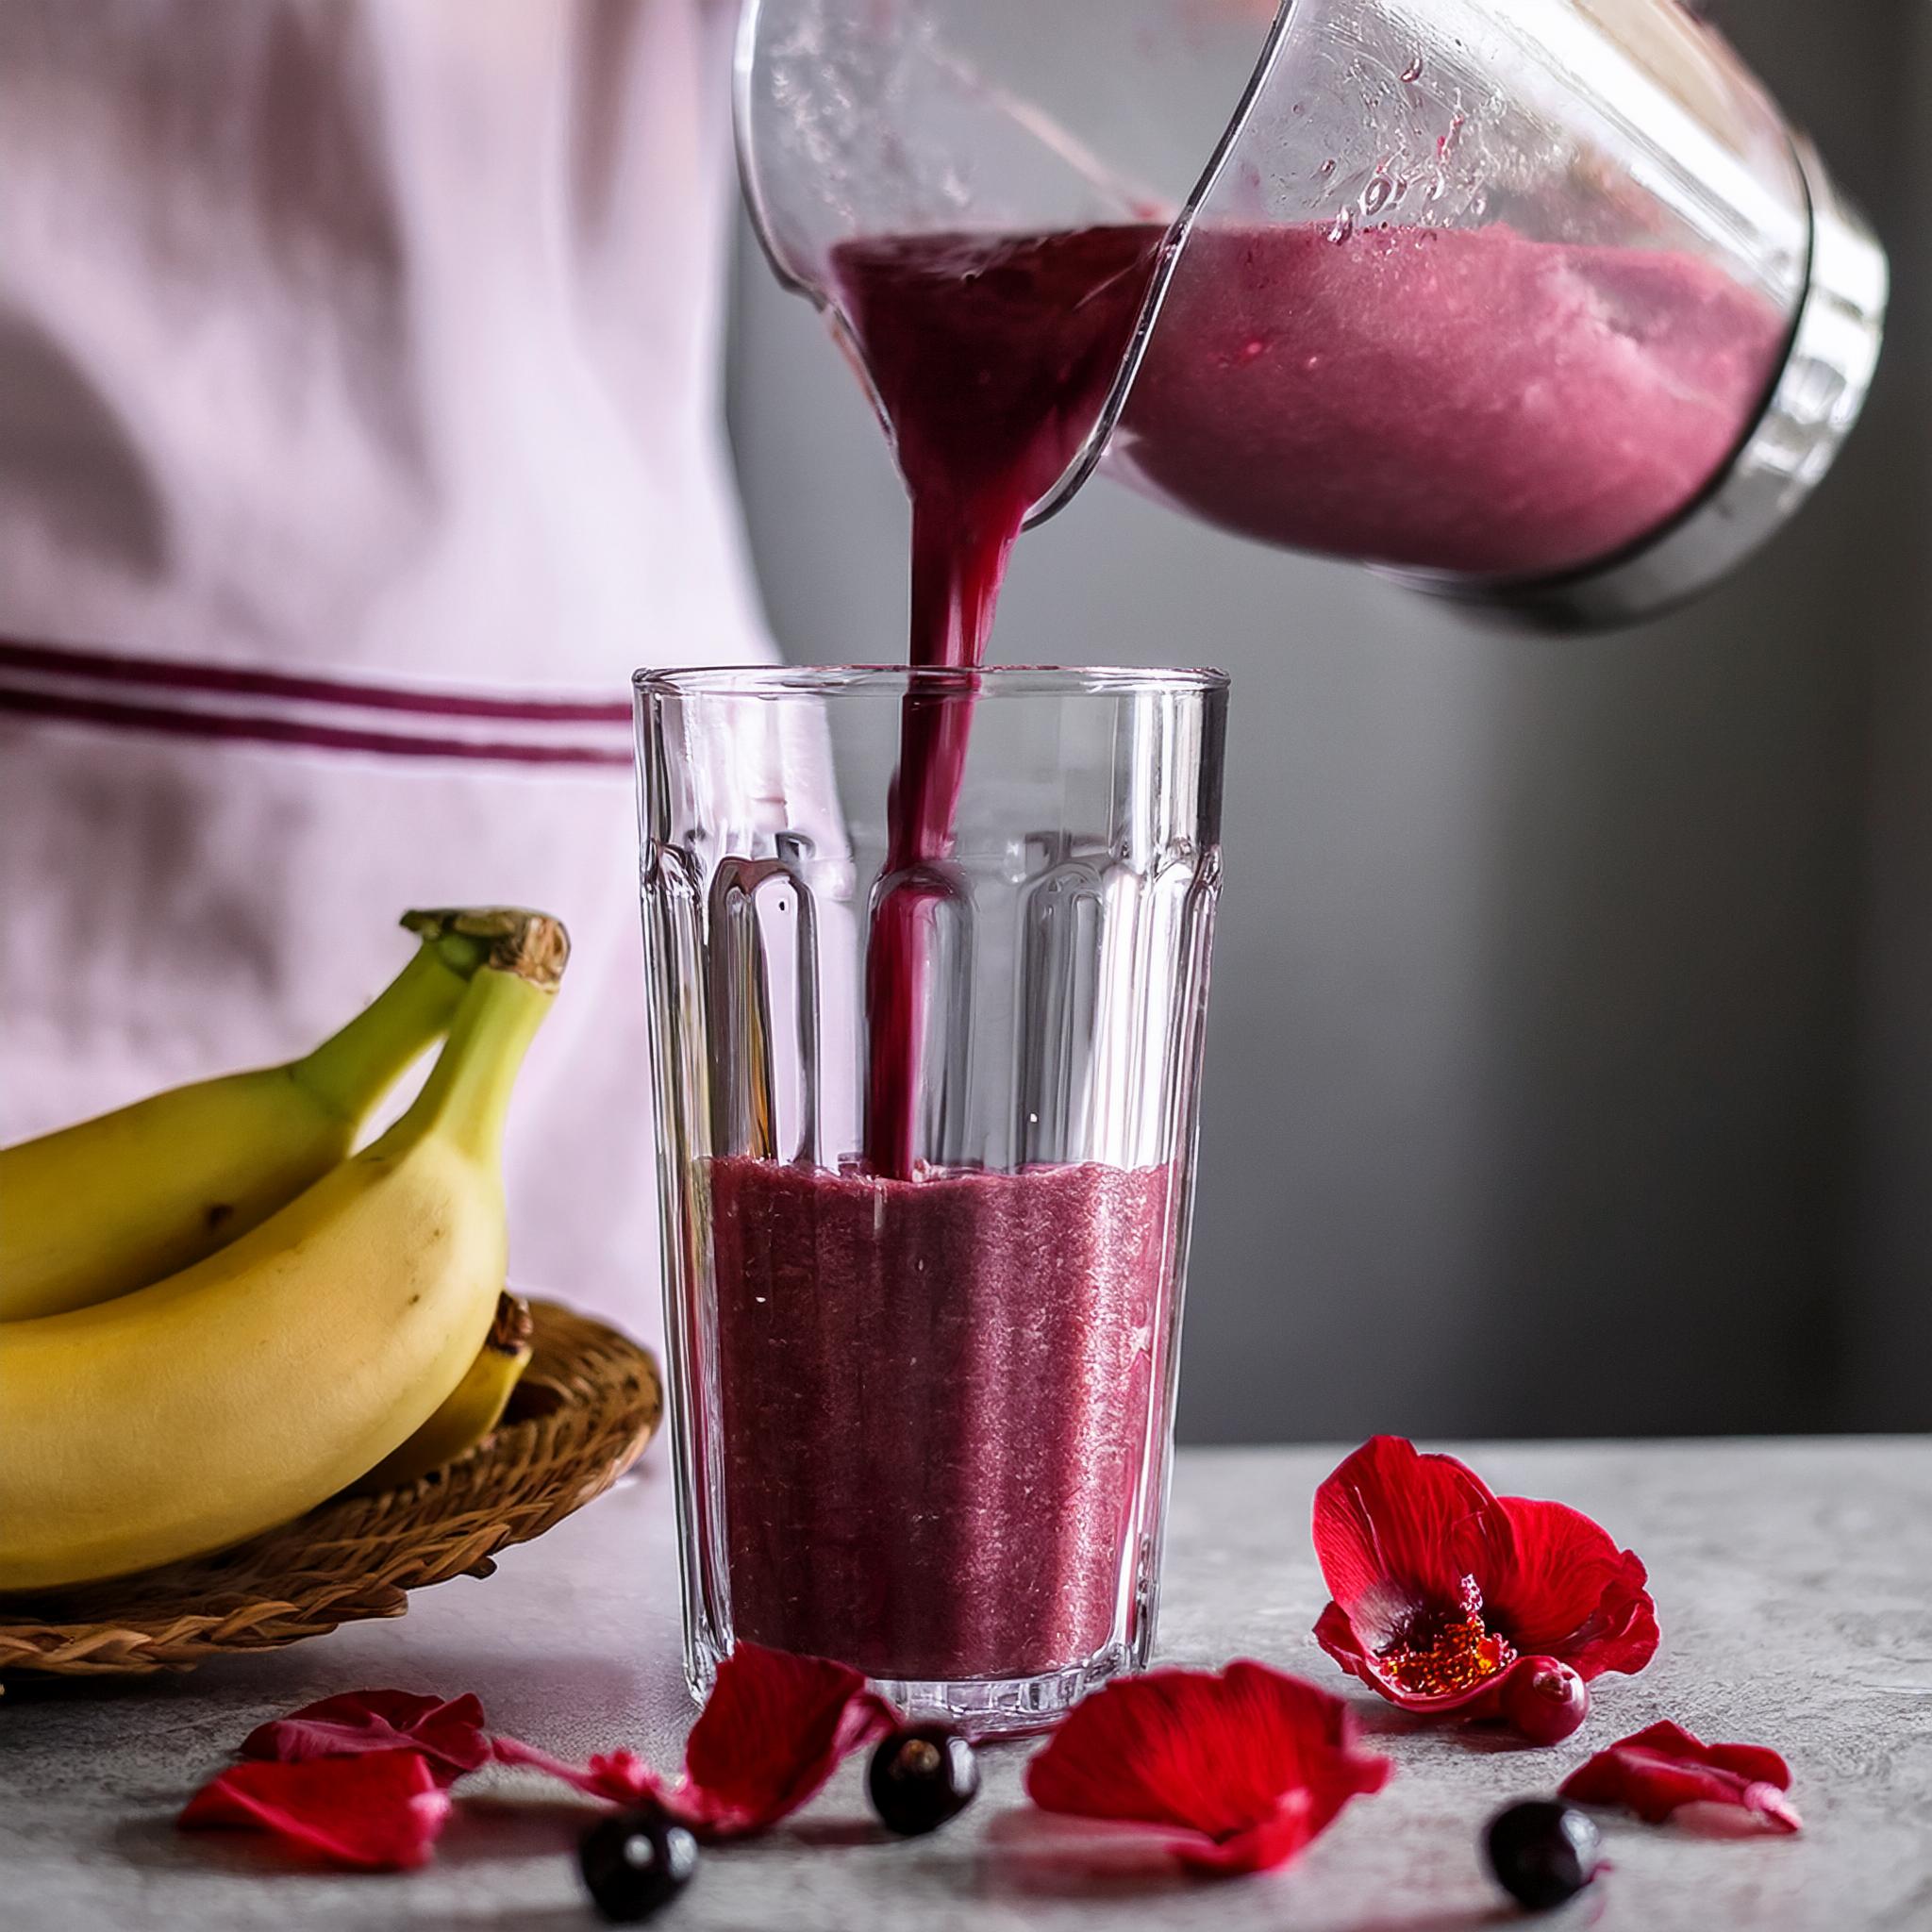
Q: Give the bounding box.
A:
[0,912,502,1322]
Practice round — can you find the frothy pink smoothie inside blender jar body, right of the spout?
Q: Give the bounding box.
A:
[1111,226,1787,575]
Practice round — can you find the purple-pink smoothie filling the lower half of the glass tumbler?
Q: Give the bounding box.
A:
[709,1158,1178,1681]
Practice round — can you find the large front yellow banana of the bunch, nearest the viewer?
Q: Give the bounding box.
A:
[0,918,566,1592]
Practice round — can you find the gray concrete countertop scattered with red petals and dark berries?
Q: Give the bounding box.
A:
[0,1441,1932,1932]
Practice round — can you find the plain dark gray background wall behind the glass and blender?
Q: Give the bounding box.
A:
[730,0,1932,1441]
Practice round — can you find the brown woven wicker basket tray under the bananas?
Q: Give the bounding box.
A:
[0,1302,662,1677]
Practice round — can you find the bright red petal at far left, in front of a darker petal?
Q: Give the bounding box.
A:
[177,1750,450,1873]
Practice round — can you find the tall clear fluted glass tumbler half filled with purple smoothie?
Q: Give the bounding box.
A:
[636,669,1226,1733]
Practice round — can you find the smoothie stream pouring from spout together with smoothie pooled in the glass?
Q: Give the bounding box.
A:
[709,215,1174,1681]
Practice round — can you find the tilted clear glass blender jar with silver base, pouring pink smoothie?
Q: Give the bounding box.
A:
[738,0,1886,628]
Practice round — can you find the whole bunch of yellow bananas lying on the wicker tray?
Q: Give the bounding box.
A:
[0,914,568,1592]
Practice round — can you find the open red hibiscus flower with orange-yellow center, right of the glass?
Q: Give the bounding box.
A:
[1314,1436,1657,1735]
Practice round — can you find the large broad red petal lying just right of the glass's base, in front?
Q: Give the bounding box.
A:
[1025,1661,1395,1873]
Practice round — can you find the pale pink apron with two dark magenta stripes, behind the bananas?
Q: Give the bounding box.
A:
[0,0,769,1333]
